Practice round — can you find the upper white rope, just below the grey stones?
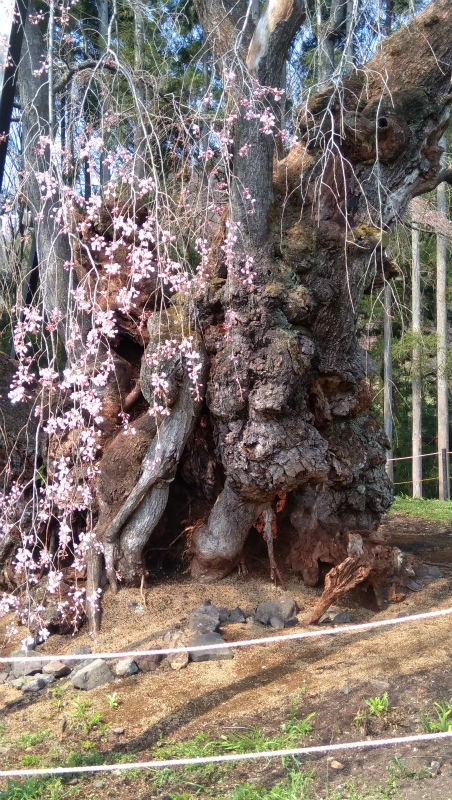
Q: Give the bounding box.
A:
[0,608,452,664]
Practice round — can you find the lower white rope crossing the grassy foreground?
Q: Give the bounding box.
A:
[0,731,452,778]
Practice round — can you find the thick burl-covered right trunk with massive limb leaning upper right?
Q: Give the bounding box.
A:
[188,0,452,581]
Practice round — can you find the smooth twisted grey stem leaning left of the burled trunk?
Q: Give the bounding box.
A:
[85,320,205,633]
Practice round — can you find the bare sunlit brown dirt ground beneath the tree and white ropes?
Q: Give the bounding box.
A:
[0,515,452,800]
